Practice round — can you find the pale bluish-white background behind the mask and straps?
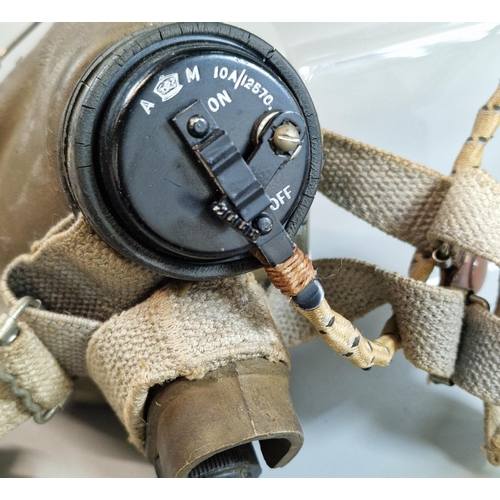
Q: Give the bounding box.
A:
[0,23,500,477]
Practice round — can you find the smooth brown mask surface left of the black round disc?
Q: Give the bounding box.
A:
[0,23,156,280]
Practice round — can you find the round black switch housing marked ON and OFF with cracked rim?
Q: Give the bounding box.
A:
[64,23,322,280]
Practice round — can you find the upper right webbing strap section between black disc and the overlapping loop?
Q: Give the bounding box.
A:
[319,130,452,251]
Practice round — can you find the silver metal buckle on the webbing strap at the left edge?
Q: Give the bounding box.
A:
[0,296,59,424]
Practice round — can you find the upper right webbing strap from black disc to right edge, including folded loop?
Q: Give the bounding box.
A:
[319,131,500,265]
